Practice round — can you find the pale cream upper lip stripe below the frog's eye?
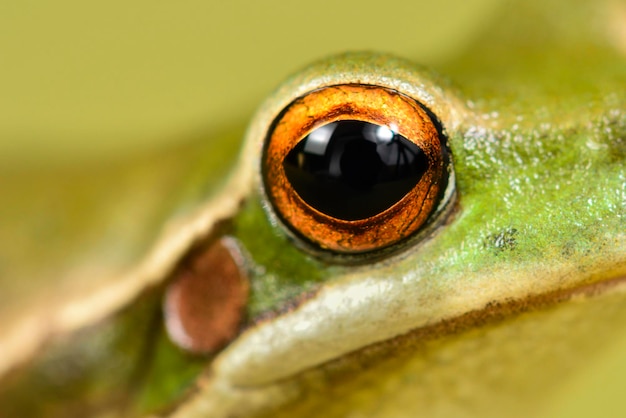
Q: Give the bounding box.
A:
[213,238,626,387]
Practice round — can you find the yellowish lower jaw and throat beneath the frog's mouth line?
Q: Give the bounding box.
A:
[173,280,626,418]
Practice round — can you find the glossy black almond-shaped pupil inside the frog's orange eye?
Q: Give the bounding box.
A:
[283,120,428,221]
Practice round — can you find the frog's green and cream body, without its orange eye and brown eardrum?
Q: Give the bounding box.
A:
[0,2,626,417]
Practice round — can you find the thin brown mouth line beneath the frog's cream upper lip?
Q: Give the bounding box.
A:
[171,266,626,416]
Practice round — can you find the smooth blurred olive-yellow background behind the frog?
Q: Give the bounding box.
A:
[0,0,626,417]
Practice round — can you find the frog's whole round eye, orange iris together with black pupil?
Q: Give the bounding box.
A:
[263,84,448,253]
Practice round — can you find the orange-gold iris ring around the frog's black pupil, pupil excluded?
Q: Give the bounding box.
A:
[263,84,448,254]
